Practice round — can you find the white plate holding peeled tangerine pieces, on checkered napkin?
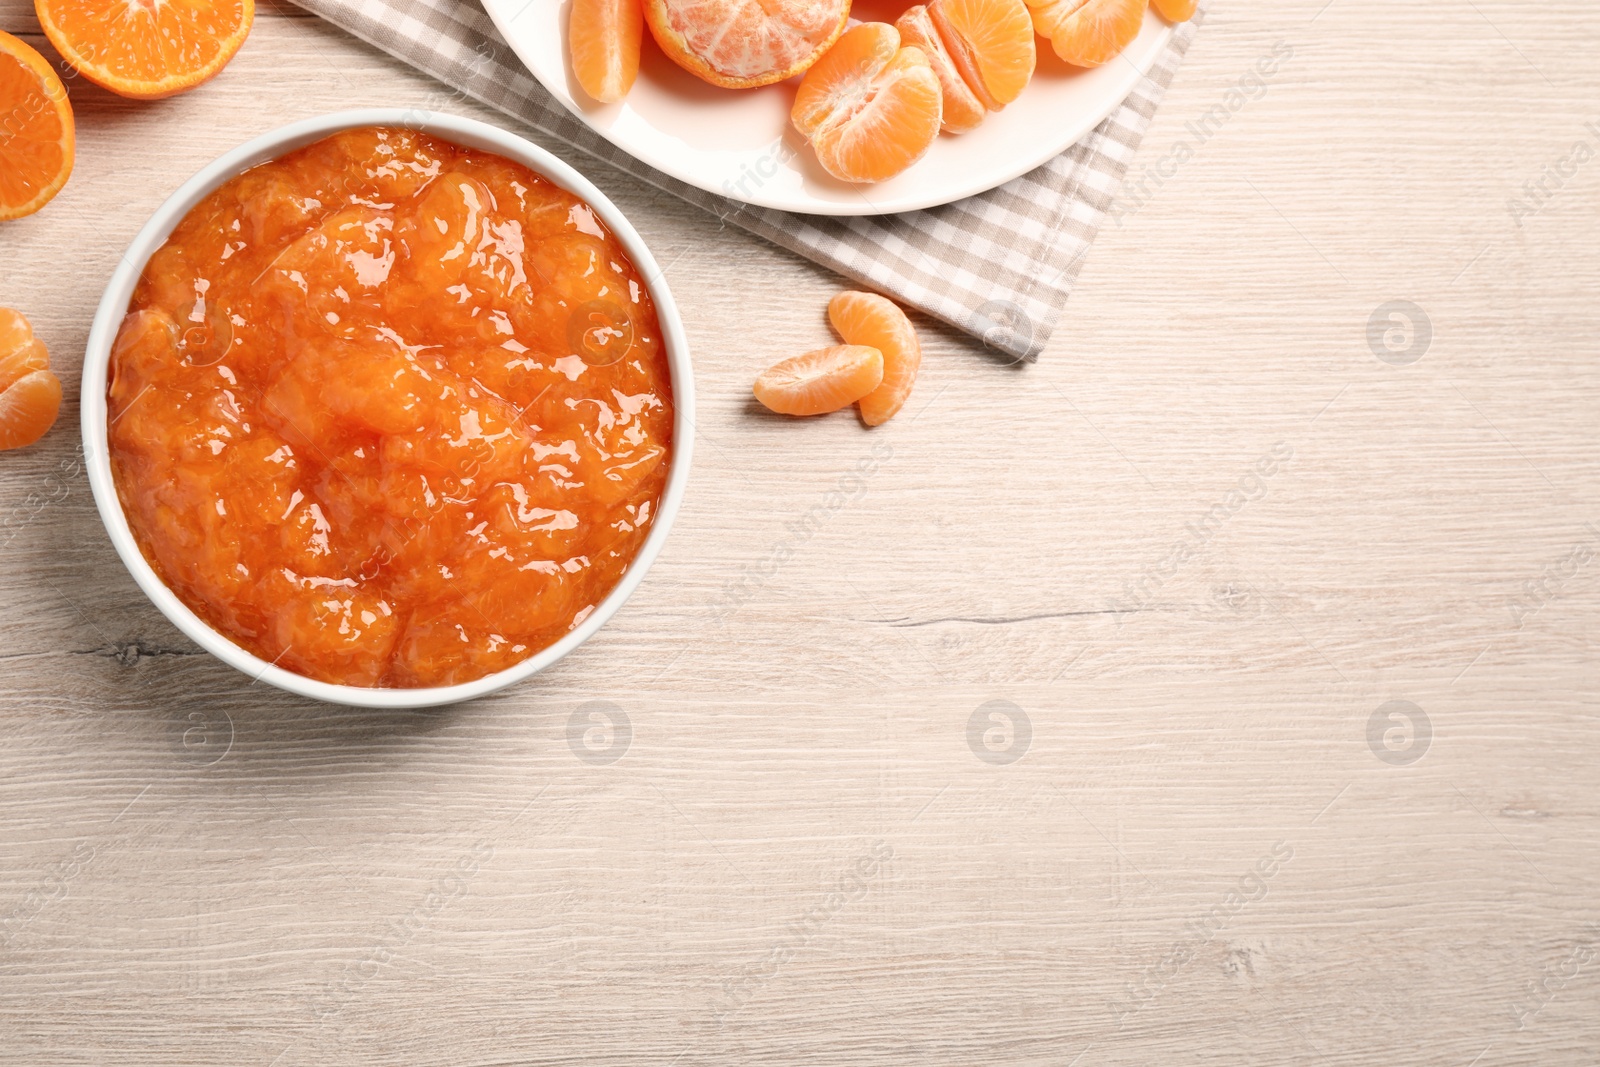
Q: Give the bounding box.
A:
[483,0,1173,214]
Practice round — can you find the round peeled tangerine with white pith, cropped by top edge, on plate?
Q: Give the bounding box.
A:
[645,0,850,90]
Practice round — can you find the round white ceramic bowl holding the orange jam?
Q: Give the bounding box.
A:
[83,109,694,707]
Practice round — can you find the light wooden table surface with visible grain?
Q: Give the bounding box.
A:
[0,0,1600,1067]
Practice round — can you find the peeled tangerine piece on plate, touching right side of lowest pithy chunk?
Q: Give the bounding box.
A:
[894,0,1035,133]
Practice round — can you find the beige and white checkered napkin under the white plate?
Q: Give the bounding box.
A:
[284,0,1200,360]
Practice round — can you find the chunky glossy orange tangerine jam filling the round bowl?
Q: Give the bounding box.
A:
[107,128,672,688]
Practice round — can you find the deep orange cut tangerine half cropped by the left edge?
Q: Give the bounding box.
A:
[0,30,74,219]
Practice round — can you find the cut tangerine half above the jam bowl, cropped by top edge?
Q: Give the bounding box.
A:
[34,0,256,101]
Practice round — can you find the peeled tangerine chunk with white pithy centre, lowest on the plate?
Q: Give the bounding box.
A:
[790,22,944,182]
